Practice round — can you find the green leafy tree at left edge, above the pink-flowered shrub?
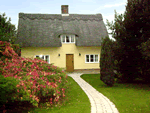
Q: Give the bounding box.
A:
[0,13,17,44]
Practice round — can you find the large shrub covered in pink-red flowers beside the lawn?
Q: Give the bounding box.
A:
[0,41,67,112]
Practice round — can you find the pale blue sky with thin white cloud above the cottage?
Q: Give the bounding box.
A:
[0,0,127,38]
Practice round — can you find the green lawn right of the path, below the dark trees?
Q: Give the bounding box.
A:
[81,74,150,113]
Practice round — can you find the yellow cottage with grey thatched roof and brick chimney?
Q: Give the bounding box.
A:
[15,5,108,72]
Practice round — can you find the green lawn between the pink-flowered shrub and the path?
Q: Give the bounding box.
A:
[30,76,91,113]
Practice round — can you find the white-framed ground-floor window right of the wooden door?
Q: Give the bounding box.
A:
[85,54,99,63]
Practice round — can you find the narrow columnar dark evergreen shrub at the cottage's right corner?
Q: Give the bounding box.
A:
[100,37,115,86]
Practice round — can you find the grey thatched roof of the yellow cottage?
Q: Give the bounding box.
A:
[15,13,108,47]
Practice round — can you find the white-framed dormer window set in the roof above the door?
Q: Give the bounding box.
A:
[61,35,75,43]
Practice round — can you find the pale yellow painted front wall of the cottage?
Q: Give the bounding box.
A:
[21,43,101,69]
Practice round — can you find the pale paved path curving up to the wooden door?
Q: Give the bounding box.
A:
[68,73,119,113]
